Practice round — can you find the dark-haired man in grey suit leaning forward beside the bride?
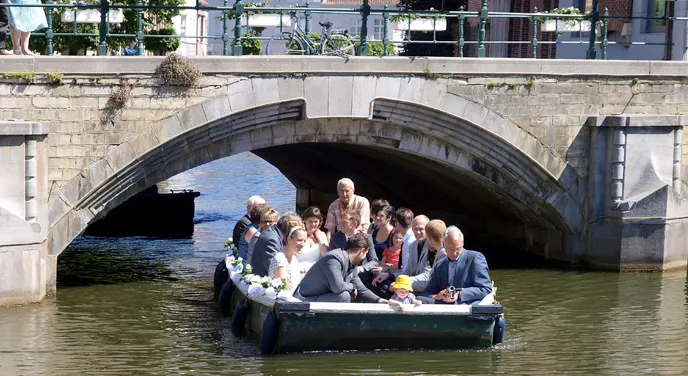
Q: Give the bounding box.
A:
[293,233,398,306]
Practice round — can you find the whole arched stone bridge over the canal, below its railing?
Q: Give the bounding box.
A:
[0,56,688,304]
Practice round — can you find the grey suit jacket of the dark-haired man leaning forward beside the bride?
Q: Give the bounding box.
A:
[296,248,380,303]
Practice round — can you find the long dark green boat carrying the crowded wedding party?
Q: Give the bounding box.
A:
[227,280,505,355]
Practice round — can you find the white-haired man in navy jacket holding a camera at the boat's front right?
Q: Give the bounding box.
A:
[418,226,492,304]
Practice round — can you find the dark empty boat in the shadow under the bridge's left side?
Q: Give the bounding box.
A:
[84,185,201,238]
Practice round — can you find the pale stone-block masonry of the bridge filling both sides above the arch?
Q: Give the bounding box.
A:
[0,58,688,203]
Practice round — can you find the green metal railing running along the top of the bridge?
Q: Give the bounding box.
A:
[0,0,687,59]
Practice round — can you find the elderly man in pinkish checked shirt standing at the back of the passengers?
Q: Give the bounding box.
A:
[325,178,370,238]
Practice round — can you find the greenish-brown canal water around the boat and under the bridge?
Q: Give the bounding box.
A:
[0,154,688,376]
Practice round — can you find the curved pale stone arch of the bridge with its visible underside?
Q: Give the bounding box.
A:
[48,76,584,261]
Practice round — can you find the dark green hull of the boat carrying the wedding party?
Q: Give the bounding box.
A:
[232,288,501,353]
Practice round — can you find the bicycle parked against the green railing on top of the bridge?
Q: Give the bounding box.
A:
[265,11,356,57]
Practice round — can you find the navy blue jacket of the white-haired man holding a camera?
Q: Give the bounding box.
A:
[421,249,492,304]
